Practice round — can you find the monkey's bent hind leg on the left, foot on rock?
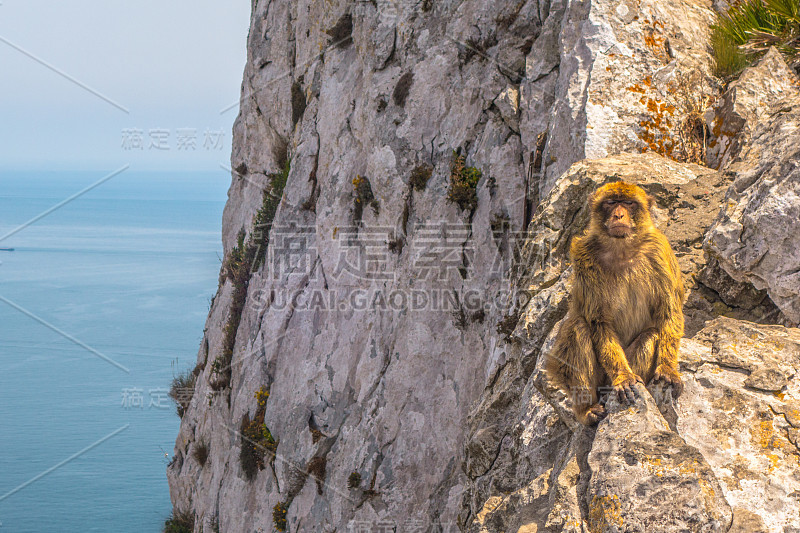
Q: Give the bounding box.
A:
[545,316,607,425]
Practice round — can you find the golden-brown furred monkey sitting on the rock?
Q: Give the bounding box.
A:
[544,182,684,425]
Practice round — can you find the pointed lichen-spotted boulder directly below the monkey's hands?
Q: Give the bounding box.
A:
[586,384,732,533]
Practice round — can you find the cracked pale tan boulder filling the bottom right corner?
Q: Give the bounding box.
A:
[675,318,800,531]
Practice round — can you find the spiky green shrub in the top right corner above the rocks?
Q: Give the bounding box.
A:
[711,0,800,77]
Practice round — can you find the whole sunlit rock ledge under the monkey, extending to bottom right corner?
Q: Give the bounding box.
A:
[472,318,800,532]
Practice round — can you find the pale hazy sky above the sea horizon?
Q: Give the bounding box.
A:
[0,0,250,171]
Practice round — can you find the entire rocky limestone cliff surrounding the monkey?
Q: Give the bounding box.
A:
[167,0,800,532]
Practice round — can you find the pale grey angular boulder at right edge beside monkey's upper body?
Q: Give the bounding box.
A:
[705,84,800,324]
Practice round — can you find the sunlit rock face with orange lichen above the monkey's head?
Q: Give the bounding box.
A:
[520,0,715,198]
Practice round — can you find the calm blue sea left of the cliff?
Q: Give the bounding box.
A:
[0,169,229,533]
